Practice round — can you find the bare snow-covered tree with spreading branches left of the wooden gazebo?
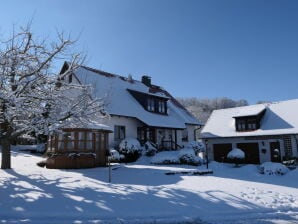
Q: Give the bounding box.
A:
[0,26,104,169]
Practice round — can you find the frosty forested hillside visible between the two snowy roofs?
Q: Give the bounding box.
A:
[177,97,255,123]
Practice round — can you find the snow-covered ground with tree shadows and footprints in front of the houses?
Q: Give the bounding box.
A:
[0,151,298,224]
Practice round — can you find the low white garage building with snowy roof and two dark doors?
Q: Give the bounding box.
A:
[201,99,298,164]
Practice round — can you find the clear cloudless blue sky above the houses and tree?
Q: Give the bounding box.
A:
[0,0,298,104]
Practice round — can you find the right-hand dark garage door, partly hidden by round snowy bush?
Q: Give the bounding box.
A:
[237,143,260,164]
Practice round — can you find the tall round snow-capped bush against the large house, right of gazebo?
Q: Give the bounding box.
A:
[119,138,142,163]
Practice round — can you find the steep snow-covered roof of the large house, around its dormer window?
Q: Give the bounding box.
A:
[74,66,201,129]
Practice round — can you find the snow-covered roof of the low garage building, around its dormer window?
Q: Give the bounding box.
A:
[201,99,298,138]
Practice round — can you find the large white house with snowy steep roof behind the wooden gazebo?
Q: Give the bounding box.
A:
[62,63,201,149]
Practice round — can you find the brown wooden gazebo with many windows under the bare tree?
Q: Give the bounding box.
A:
[46,125,112,169]
